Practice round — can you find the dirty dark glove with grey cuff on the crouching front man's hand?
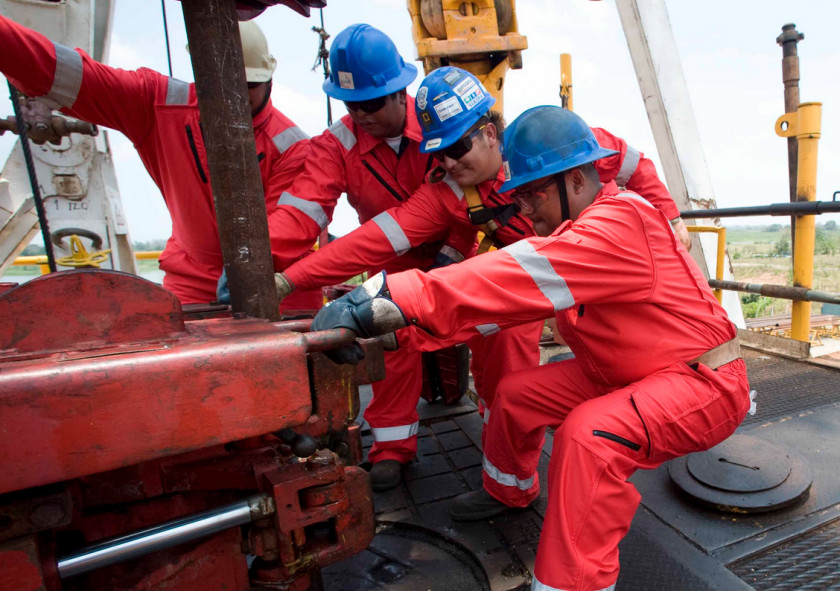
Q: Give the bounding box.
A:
[310,272,408,365]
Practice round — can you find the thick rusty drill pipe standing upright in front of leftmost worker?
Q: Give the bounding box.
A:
[181,0,279,320]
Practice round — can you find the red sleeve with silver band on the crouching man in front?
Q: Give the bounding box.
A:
[387,201,663,341]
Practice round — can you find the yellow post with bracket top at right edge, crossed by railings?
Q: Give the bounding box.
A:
[776,103,822,342]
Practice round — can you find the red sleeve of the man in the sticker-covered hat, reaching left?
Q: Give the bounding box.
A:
[285,183,457,289]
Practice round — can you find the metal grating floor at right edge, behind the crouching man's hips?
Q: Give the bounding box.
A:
[742,349,840,425]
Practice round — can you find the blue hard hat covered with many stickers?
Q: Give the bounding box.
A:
[414,66,496,153]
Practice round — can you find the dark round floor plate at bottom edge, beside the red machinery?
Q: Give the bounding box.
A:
[321,522,490,591]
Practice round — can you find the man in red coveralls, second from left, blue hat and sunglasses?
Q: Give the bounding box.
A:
[268,24,486,490]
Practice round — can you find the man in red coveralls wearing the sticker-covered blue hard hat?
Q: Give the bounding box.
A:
[278,67,688,494]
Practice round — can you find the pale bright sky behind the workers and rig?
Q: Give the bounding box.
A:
[0,0,840,240]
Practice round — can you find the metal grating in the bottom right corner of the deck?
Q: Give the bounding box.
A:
[729,520,840,591]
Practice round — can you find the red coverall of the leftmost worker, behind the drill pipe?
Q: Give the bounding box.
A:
[0,17,321,308]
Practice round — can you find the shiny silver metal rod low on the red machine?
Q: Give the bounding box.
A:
[57,494,275,579]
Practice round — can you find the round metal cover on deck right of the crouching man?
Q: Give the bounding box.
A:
[668,434,813,513]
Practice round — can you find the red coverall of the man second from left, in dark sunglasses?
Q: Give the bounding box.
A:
[268,96,456,462]
